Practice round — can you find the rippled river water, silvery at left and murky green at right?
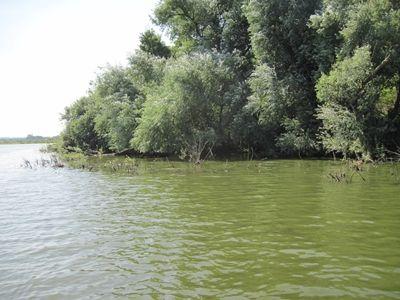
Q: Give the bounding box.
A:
[0,145,400,299]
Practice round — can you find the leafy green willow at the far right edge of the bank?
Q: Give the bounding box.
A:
[317,0,400,156]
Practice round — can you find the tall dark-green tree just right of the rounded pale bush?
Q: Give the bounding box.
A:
[246,0,321,152]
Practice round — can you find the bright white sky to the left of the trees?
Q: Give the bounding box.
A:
[0,0,158,137]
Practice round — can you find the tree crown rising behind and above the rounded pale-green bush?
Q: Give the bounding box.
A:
[154,0,253,79]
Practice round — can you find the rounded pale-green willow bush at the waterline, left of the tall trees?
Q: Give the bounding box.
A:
[132,53,242,160]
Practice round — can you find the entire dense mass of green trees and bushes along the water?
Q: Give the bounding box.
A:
[62,0,400,161]
